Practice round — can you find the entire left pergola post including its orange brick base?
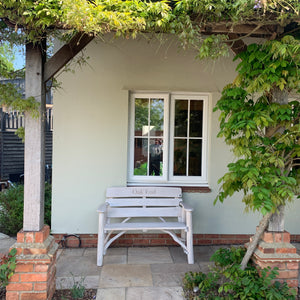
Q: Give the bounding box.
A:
[6,43,58,300]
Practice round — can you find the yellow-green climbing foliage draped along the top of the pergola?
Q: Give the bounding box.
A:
[0,0,300,118]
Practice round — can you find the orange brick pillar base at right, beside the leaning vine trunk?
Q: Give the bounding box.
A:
[252,231,300,289]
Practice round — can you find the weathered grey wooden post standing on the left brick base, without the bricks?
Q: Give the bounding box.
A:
[23,43,46,231]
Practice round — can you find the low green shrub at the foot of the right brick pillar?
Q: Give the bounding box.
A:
[183,247,295,300]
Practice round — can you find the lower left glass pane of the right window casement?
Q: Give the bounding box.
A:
[173,139,187,176]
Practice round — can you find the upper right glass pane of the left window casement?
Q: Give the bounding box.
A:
[150,99,164,136]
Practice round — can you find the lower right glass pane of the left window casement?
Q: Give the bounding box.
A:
[149,139,163,176]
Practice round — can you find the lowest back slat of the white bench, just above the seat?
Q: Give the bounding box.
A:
[107,207,180,218]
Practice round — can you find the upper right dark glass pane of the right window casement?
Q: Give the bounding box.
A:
[190,100,203,137]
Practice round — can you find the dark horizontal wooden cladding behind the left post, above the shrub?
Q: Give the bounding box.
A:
[0,131,52,180]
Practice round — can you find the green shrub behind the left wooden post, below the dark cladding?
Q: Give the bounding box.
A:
[0,183,51,236]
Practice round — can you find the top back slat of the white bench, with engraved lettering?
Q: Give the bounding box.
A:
[106,187,182,198]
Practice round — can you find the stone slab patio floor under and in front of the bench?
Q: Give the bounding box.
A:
[56,246,220,300]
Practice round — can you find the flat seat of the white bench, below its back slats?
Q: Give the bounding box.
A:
[104,222,186,230]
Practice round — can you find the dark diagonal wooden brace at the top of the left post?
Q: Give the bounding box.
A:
[44,33,94,82]
